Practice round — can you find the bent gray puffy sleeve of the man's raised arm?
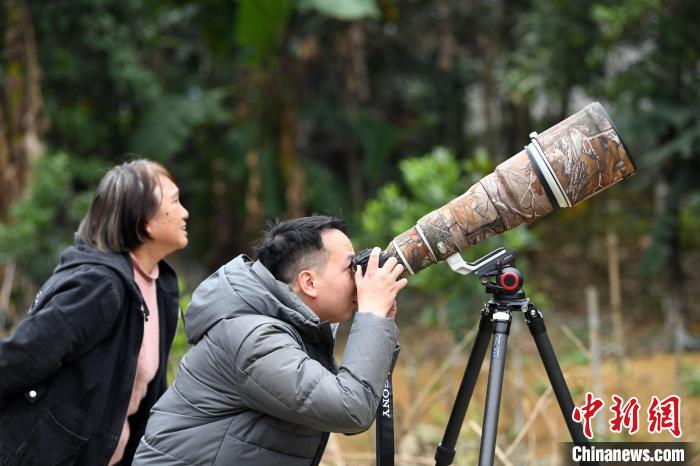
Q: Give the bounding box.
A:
[230,314,398,433]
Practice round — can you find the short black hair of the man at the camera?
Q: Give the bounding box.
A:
[255,215,346,284]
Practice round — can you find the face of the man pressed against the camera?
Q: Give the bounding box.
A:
[308,230,357,323]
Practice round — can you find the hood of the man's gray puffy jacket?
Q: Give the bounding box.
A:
[184,255,321,344]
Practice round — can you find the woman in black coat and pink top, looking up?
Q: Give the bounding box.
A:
[0,160,188,466]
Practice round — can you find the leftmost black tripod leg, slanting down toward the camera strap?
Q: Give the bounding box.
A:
[435,314,493,466]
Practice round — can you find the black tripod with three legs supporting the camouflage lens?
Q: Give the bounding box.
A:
[435,248,592,466]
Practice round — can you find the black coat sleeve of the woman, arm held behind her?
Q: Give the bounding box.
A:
[0,267,123,399]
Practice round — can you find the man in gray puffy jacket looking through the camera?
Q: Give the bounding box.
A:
[134,216,406,466]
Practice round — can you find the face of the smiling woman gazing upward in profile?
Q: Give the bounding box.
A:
[145,175,189,257]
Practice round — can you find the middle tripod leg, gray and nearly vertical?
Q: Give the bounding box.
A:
[479,312,511,466]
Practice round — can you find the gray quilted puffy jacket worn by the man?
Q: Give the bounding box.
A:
[133,256,398,466]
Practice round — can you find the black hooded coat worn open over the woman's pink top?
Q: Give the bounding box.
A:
[0,244,179,466]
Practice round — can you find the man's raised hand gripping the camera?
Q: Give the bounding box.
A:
[355,248,408,318]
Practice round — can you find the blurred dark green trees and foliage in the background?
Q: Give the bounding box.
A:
[0,0,700,346]
